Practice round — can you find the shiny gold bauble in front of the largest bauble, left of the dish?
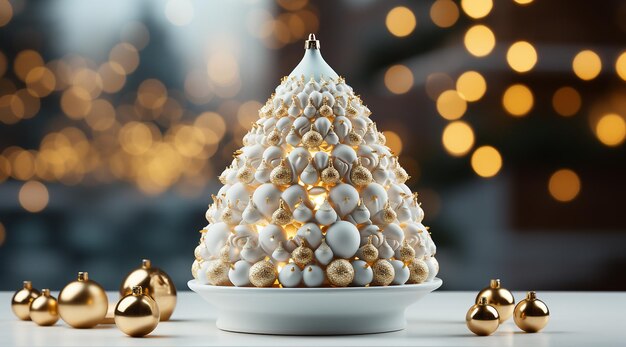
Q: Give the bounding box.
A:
[115,286,160,337]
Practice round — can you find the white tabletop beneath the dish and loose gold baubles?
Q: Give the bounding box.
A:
[0,292,626,347]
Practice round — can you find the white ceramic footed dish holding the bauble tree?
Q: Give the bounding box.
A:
[187,278,443,335]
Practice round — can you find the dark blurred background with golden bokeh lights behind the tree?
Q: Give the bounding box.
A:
[0,0,626,290]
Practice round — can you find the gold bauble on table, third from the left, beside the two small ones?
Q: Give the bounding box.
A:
[59,272,109,329]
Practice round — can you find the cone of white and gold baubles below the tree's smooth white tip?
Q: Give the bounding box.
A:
[192,76,439,287]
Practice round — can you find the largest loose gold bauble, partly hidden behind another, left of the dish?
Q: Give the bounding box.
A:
[120,259,176,321]
